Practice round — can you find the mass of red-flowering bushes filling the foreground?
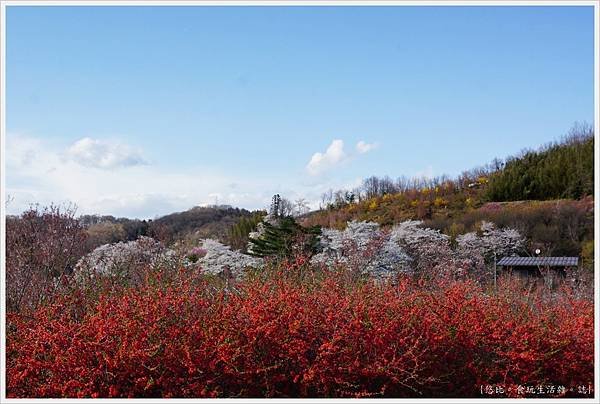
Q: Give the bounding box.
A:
[7,262,594,397]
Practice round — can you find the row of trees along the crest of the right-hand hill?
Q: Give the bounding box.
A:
[321,124,594,209]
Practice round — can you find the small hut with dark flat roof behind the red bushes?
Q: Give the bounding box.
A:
[496,257,579,286]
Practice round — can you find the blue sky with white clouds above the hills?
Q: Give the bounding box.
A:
[6,6,594,217]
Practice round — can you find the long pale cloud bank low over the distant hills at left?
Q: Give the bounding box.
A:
[6,134,283,218]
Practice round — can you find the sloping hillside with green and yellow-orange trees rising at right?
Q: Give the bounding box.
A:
[302,126,594,260]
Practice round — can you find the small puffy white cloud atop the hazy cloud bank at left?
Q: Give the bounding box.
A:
[66,137,147,169]
